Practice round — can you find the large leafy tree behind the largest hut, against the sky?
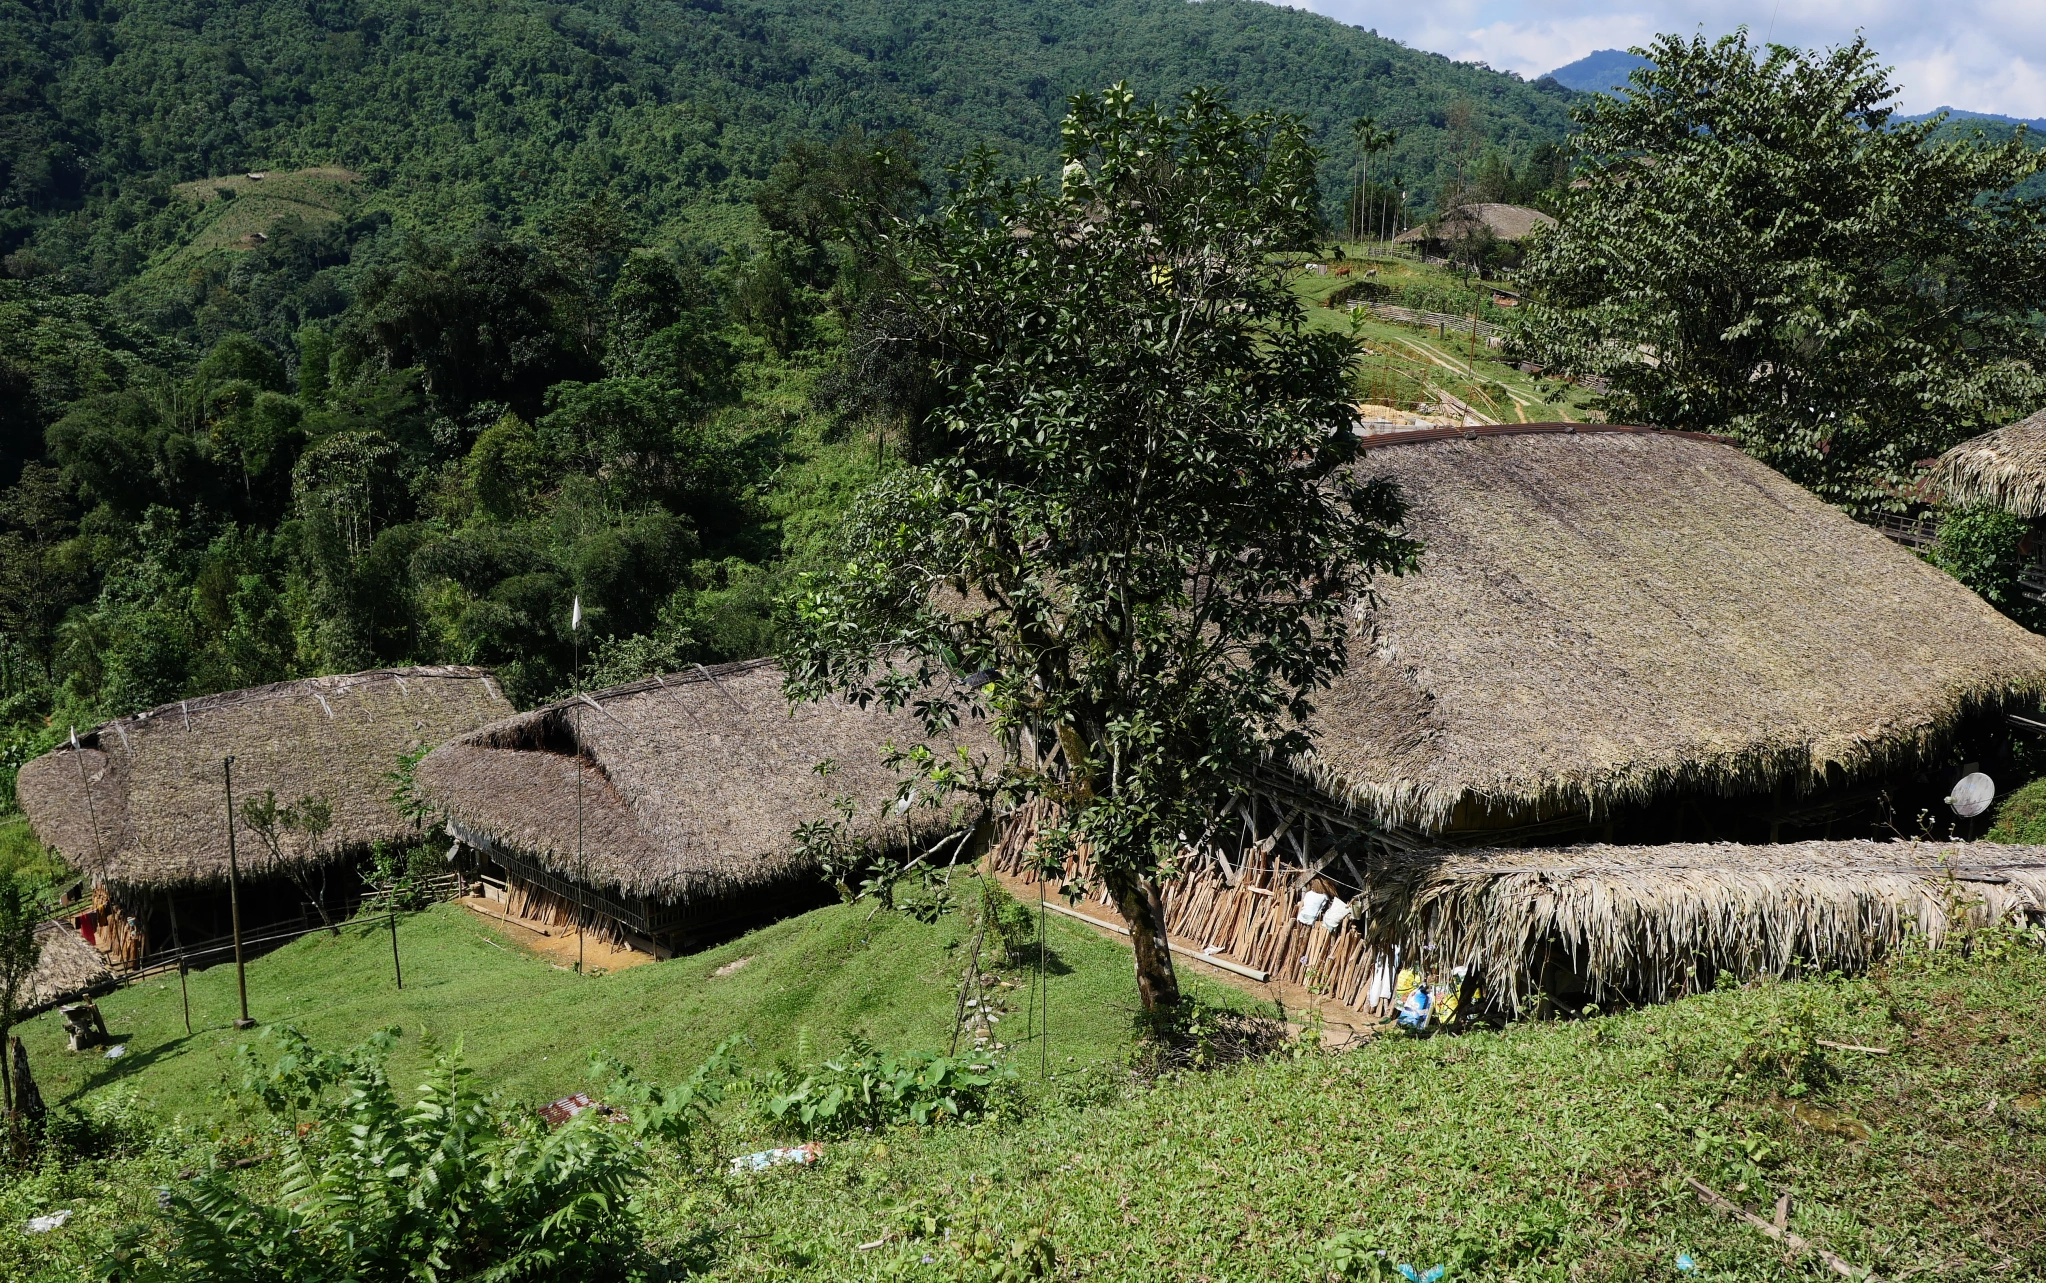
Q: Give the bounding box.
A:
[1518,29,2046,512]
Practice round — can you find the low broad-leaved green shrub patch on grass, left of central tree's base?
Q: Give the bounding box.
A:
[759,1037,1015,1138]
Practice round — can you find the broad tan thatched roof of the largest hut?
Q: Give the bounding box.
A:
[1301,426,2046,831]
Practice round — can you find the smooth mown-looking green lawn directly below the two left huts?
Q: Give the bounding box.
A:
[23,904,1243,1117]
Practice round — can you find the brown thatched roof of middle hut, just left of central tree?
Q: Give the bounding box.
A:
[417,661,990,900]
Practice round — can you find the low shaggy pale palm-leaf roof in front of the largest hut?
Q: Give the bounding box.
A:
[1361,841,2046,1009]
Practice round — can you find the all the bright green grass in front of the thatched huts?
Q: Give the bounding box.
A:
[0,906,2046,1283]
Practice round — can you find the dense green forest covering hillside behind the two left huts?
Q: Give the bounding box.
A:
[0,0,1571,810]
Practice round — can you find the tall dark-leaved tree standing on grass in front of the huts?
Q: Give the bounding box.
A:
[788,86,1412,1011]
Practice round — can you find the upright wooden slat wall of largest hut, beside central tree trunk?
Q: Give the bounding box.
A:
[990,798,1389,1015]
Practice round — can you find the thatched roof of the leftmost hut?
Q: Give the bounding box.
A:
[18,667,512,888]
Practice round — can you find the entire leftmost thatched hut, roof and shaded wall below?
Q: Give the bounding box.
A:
[18,667,512,966]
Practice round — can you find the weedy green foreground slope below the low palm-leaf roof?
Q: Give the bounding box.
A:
[675,947,2046,1283]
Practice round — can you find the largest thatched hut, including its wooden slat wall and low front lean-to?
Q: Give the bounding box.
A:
[994,424,2046,1005]
